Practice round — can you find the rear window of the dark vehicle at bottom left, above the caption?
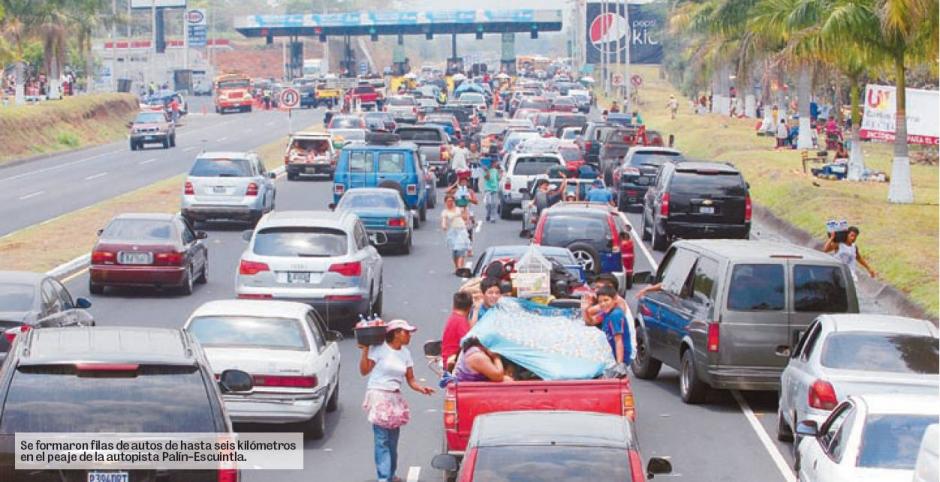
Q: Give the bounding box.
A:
[0,365,221,433]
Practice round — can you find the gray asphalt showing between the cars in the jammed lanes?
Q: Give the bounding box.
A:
[60,171,793,482]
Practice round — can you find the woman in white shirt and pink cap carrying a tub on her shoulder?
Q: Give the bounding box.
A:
[359,320,434,482]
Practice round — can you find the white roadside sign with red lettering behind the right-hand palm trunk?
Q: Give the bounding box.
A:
[859,84,940,145]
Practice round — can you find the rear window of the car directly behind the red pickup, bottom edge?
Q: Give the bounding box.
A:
[473,445,639,482]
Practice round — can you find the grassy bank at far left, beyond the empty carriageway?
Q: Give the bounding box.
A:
[0,94,138,165]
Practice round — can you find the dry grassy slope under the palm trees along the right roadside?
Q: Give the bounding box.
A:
[599,66,940,317]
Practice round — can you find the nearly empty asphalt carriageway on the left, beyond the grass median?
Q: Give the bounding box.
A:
[0,97,323,236]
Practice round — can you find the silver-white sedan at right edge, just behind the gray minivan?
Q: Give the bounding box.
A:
[777,314,940,441]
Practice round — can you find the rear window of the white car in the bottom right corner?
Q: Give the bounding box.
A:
[858,414,940,470]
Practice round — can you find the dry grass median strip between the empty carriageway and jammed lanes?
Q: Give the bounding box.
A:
[0,124,319,272]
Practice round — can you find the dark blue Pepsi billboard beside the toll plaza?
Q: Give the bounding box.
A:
[584,2,665,64]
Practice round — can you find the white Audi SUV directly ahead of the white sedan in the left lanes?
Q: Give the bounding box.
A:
[235,211,383,329]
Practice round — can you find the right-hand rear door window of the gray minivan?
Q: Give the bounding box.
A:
[793,264,849,313]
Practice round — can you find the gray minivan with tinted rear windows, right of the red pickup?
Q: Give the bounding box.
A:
[633,239,858,403]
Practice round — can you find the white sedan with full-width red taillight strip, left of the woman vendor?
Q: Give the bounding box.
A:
[183,300,343,439]
